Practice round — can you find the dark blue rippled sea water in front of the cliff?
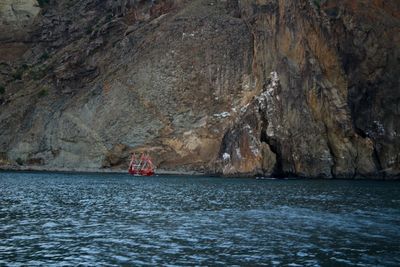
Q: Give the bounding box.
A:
[0,172,400,266]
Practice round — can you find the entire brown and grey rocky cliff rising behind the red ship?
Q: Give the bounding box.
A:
[0,0,400,178]
